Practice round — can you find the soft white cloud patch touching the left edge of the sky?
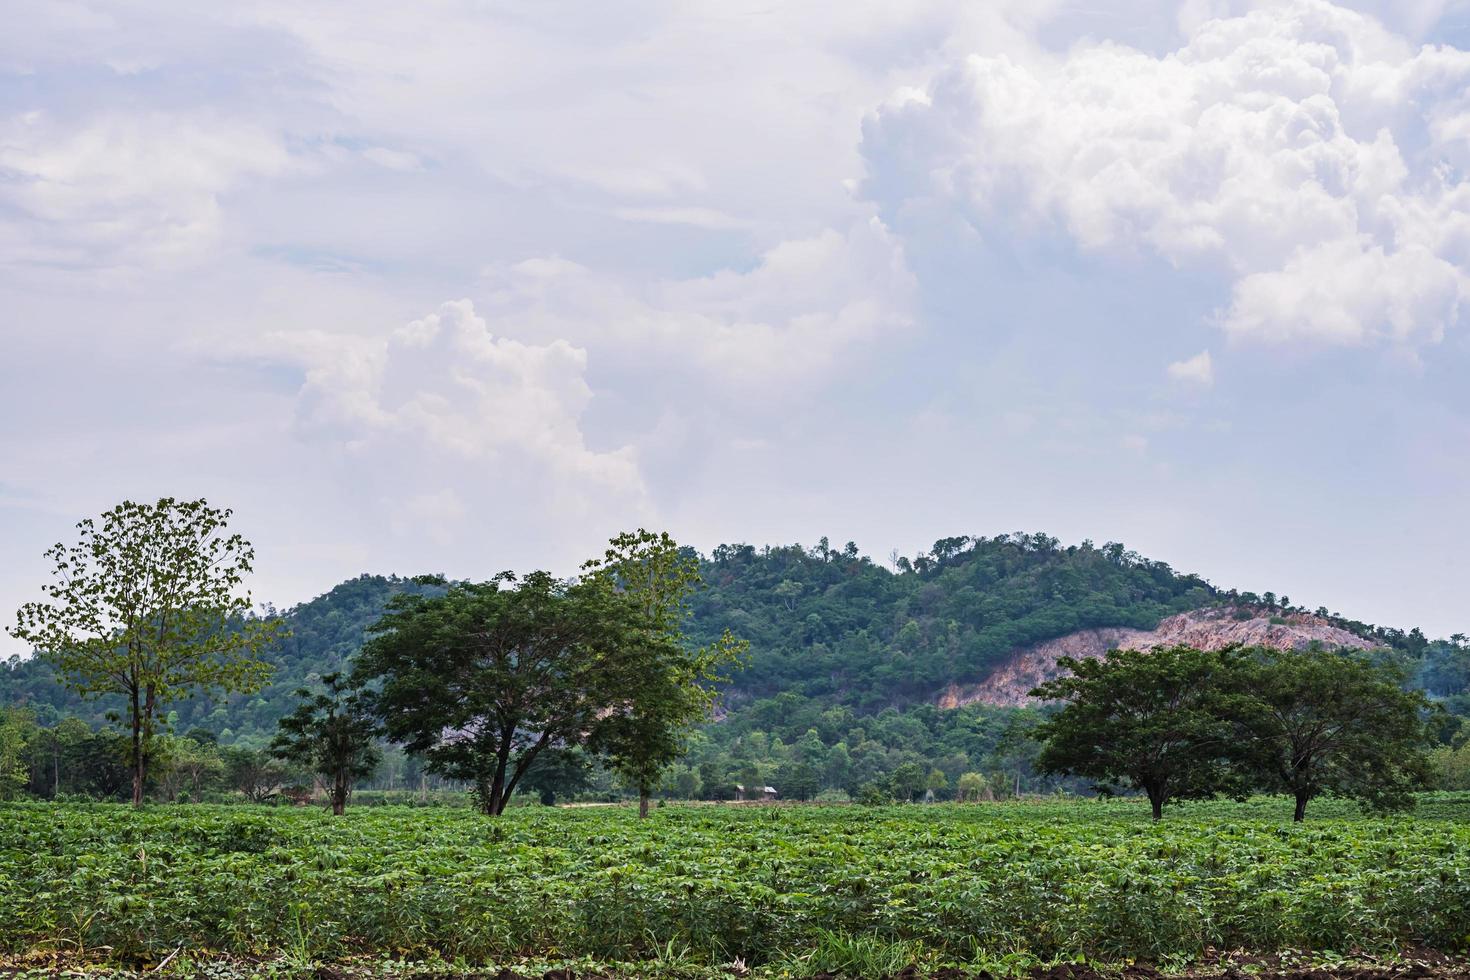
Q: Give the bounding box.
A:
[0,112,291,267]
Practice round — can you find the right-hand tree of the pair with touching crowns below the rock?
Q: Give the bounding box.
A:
[1233,648,1433,821]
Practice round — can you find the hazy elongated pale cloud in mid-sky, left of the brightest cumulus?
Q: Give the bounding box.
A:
[476,219,914,389]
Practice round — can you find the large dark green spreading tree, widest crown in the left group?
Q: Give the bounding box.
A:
[357,572,676,815]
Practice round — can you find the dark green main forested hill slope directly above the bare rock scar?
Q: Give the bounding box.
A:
[692,535,1219,713]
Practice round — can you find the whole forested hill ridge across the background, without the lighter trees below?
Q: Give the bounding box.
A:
[0,535,1470,741]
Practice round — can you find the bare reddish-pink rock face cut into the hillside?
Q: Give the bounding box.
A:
[938,608,1373,708]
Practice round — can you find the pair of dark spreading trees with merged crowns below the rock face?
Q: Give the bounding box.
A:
[1032,646,1435,821]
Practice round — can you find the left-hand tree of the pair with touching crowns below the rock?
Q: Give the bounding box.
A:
[1030,646,1233,820]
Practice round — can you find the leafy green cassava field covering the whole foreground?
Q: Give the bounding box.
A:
[0,793,1470,977]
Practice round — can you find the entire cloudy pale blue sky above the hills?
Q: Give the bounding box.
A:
[0,0,1470,654]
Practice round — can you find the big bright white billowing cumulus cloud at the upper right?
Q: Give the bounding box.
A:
[863,0,1470,347]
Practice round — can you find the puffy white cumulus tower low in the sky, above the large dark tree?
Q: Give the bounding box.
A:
[272,300,642,502]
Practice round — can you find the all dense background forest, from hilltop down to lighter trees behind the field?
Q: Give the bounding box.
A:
[0,533,1470,796]
